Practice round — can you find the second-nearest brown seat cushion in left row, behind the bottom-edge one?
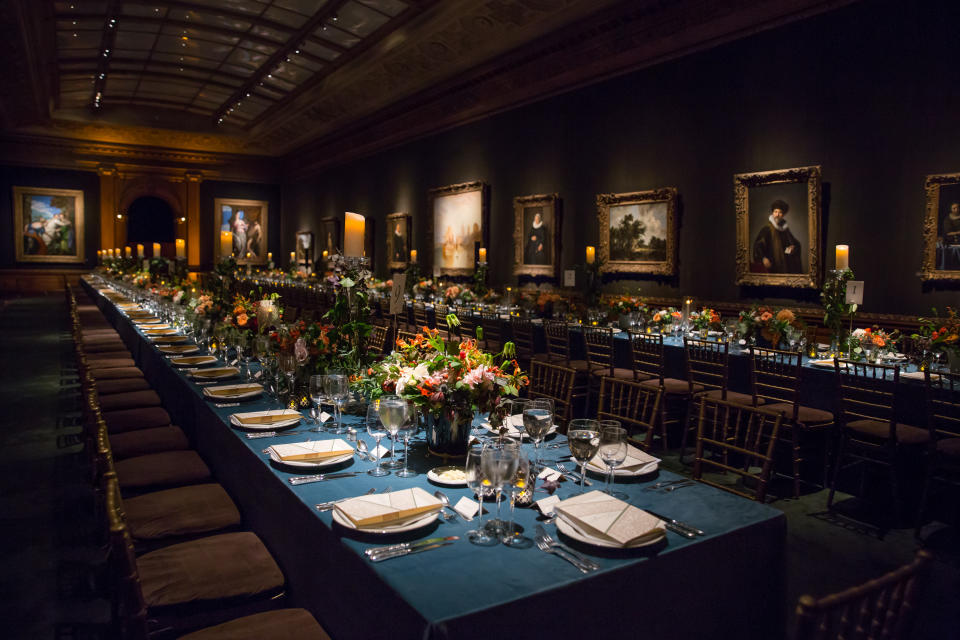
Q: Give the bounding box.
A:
[137,531,284,608]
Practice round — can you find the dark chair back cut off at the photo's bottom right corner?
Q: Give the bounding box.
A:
[794,549,933,640]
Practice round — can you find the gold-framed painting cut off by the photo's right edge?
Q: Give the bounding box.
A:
[920,173,960,282]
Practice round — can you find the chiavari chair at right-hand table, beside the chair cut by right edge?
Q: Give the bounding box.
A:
[827,358,930,526]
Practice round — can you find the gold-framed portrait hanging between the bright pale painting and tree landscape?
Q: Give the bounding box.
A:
[513,193,561,277]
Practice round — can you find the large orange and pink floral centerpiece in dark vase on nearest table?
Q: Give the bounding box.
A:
[355,328,529,457]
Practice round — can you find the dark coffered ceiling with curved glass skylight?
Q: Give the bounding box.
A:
[0,0,846,174]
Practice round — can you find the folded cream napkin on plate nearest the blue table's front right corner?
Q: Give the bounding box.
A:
[554,491,666,547]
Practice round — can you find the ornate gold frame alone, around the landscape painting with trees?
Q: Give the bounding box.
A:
[597,187,677,276]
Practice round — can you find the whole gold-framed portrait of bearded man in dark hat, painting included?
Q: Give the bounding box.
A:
[733,165,823,288]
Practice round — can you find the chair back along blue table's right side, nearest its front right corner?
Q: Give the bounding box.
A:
[693,397,783,502]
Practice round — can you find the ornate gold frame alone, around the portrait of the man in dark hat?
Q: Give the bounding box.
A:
[733,165,822,289]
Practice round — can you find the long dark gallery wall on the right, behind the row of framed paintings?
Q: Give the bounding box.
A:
[282,1,960,313]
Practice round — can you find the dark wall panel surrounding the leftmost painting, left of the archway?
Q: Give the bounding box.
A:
[0,166,100,270]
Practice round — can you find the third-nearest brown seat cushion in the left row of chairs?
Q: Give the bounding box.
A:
[123,483,240,540]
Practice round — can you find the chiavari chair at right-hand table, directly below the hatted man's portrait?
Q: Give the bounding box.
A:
[750,347,834,498]
